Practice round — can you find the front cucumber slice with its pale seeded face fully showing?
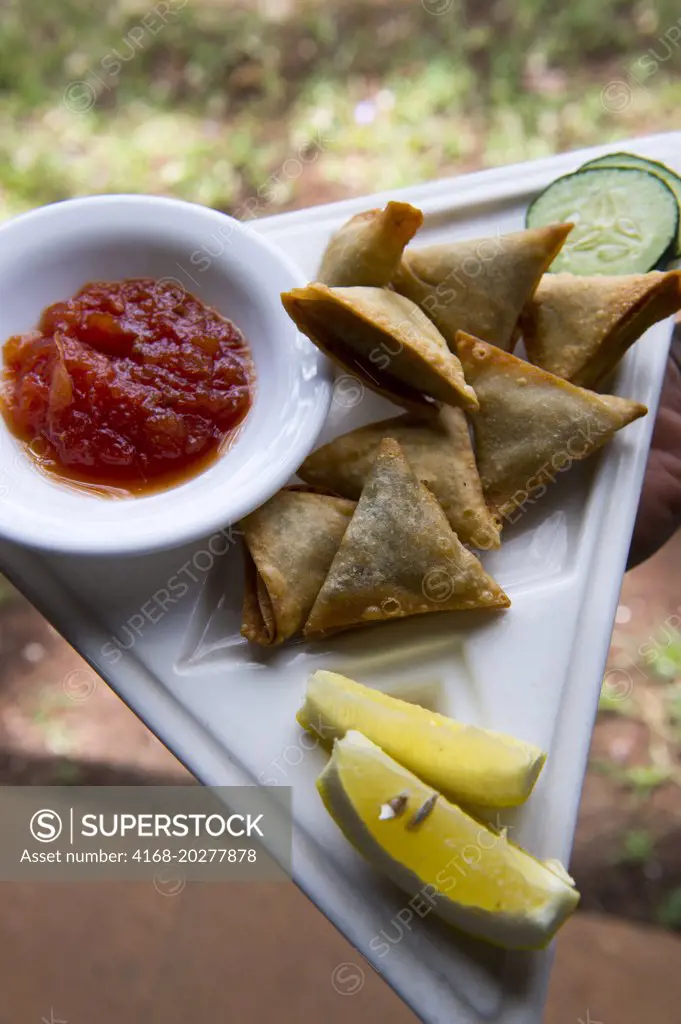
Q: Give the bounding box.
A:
[525,167,679,274]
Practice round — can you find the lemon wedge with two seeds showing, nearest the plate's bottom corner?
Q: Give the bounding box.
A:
[317,731,580,949]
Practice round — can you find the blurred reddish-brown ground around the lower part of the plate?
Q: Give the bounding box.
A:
[0,436,681,1024]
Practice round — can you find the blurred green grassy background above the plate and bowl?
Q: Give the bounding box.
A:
[0,0,681,216]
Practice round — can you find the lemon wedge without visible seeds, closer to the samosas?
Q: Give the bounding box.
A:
[297,671,546,807]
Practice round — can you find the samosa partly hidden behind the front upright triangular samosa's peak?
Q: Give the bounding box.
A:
[298,407,500,549]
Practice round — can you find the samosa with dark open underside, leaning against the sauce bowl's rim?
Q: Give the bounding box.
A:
[282,283,477,410]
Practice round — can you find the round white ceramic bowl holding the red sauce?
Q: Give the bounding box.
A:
[0,196,332,555]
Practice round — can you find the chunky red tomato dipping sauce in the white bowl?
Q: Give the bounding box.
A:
[2,278,254,495]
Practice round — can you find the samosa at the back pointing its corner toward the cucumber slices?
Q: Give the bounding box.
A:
[392,224,572,351]
